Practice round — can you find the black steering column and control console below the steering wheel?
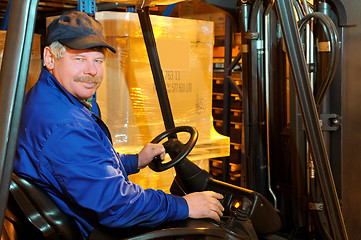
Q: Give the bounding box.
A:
[170,158,281,235]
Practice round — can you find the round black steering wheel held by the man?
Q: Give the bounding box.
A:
[148,126,198,172]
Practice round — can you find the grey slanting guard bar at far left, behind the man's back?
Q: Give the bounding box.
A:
[0,0,38,233]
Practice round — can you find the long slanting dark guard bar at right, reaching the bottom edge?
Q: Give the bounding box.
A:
[276,0,348,240]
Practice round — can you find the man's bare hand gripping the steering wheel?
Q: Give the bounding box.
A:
[138,143,165,169]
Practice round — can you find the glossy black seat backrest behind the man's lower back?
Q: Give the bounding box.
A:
[8,173,81,240]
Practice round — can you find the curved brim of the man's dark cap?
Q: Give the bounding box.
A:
[58,36,117,53]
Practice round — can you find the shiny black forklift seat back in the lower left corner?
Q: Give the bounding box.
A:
[5,173,81,240]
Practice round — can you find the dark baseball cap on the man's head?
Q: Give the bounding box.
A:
[47,11,116,53]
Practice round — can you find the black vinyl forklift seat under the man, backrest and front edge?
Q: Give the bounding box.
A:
[3,173,225,240]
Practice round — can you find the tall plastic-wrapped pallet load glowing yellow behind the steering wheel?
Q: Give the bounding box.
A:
[96,12,230,191]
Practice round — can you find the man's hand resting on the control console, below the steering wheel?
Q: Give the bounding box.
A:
[183,191,224,222]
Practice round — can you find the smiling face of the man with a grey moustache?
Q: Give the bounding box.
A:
[50,48,105,100]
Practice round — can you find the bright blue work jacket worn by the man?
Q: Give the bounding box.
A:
[14,68,189,238]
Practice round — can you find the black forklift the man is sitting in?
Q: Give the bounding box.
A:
[0,0,360,239]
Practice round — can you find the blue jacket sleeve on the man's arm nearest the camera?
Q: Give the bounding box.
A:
[39,122,189,227]
